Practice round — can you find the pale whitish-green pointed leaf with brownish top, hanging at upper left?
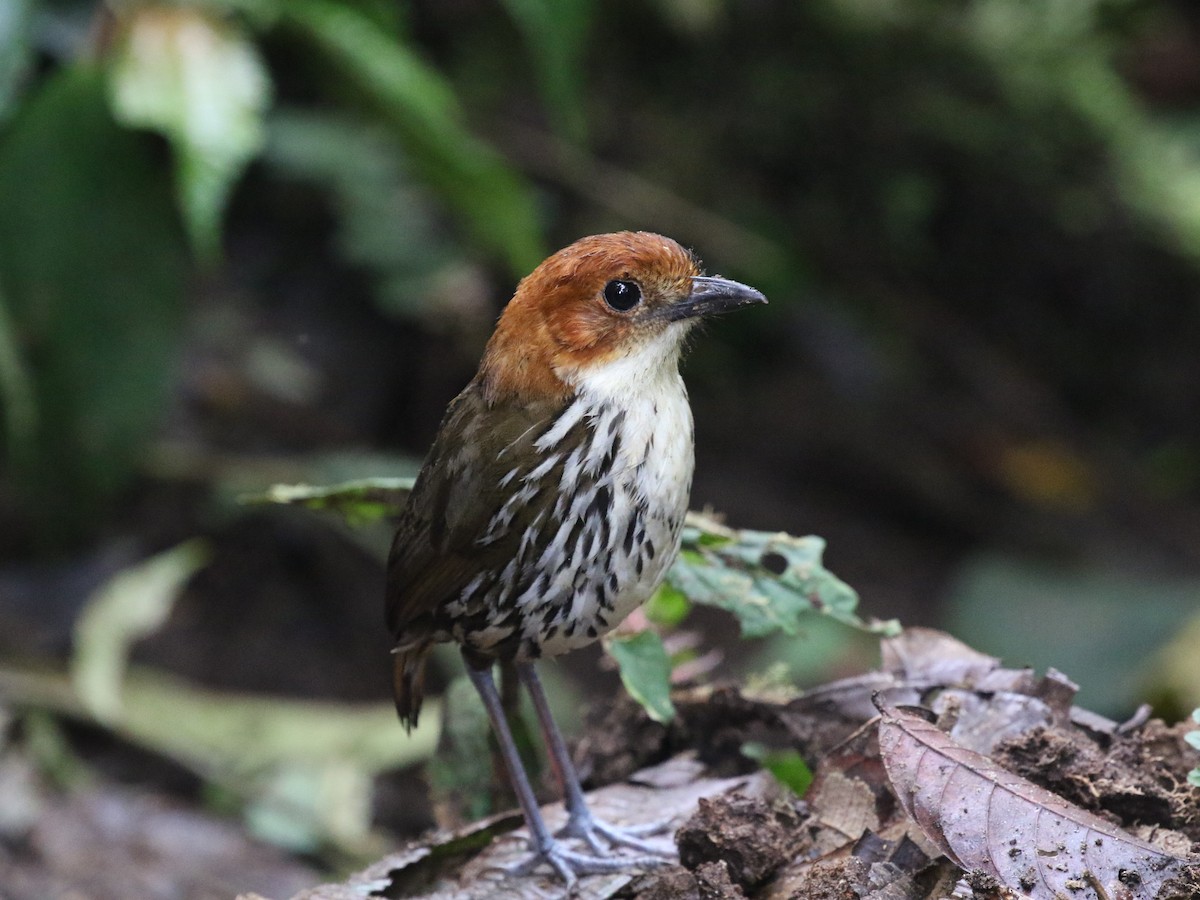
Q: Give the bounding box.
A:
[109,5,271,259]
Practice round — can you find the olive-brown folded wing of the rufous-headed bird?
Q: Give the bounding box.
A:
[388,382,566,648]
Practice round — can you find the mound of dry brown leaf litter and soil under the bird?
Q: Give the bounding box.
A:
[290,629,1200,900]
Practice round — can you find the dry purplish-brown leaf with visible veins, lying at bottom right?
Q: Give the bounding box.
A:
[880,707,1193,900]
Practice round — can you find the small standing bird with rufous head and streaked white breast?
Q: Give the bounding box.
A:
[386,232,767,886]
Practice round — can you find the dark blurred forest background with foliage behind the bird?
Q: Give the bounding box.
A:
[0,0,1200,896]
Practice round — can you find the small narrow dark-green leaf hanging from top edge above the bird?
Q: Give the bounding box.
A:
[504,0,595,143]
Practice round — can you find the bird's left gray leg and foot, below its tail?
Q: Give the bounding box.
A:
[464,654,659,886]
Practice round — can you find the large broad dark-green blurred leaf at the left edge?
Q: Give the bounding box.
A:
[0,66,188,540]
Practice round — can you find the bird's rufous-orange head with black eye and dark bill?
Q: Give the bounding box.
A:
[479,232,767,402]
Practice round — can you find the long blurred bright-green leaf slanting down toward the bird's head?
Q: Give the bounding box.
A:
[282,0,546,275]
